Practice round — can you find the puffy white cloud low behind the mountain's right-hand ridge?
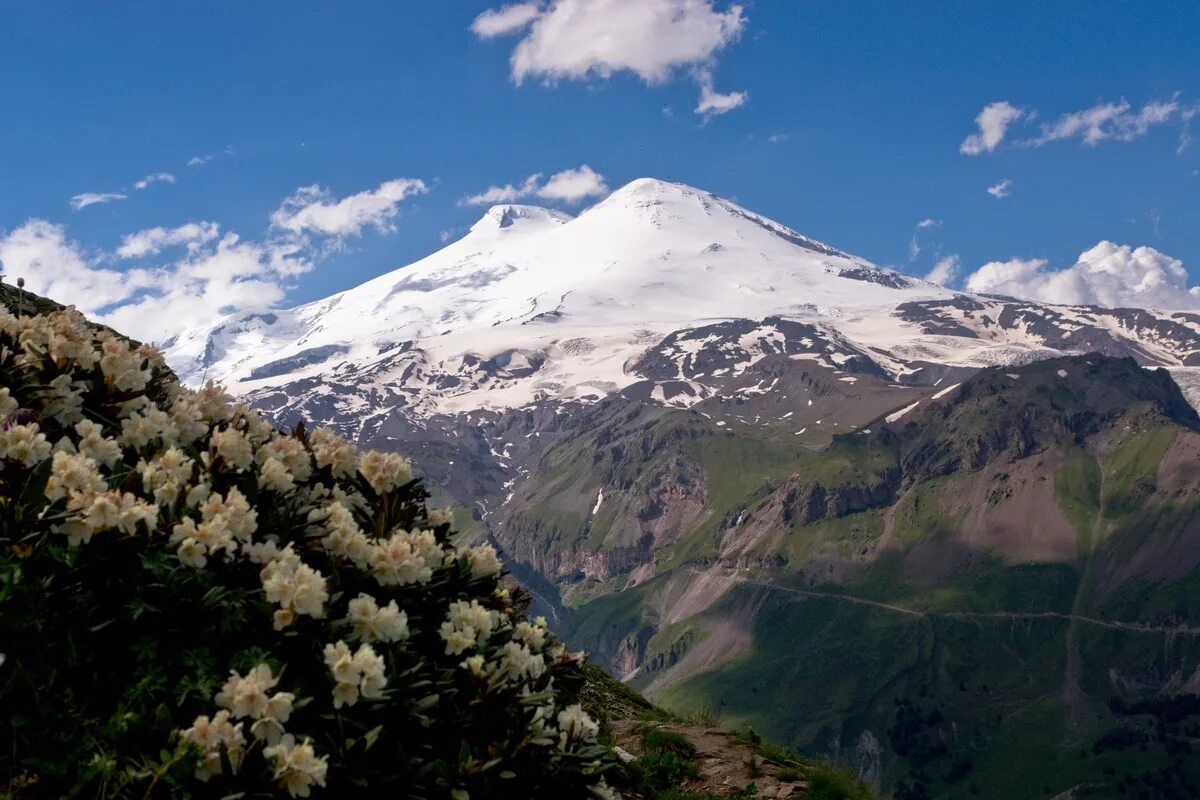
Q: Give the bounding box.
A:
[966,241,1200,309]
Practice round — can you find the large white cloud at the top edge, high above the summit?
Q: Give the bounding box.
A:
[470,0,748,115]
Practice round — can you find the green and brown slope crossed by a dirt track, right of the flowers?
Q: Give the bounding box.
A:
[554,356,1200,798]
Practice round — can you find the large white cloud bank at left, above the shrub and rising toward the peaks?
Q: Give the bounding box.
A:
[0,181,424,342]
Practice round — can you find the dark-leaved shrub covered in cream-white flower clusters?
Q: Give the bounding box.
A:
[0,304,611,800]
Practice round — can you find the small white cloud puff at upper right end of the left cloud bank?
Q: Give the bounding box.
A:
[271,178,428,239]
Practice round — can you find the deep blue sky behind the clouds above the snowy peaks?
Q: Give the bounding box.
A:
[0,0,1200,338]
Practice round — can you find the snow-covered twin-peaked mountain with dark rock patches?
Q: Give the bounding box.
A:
[168,179,1200,433]
